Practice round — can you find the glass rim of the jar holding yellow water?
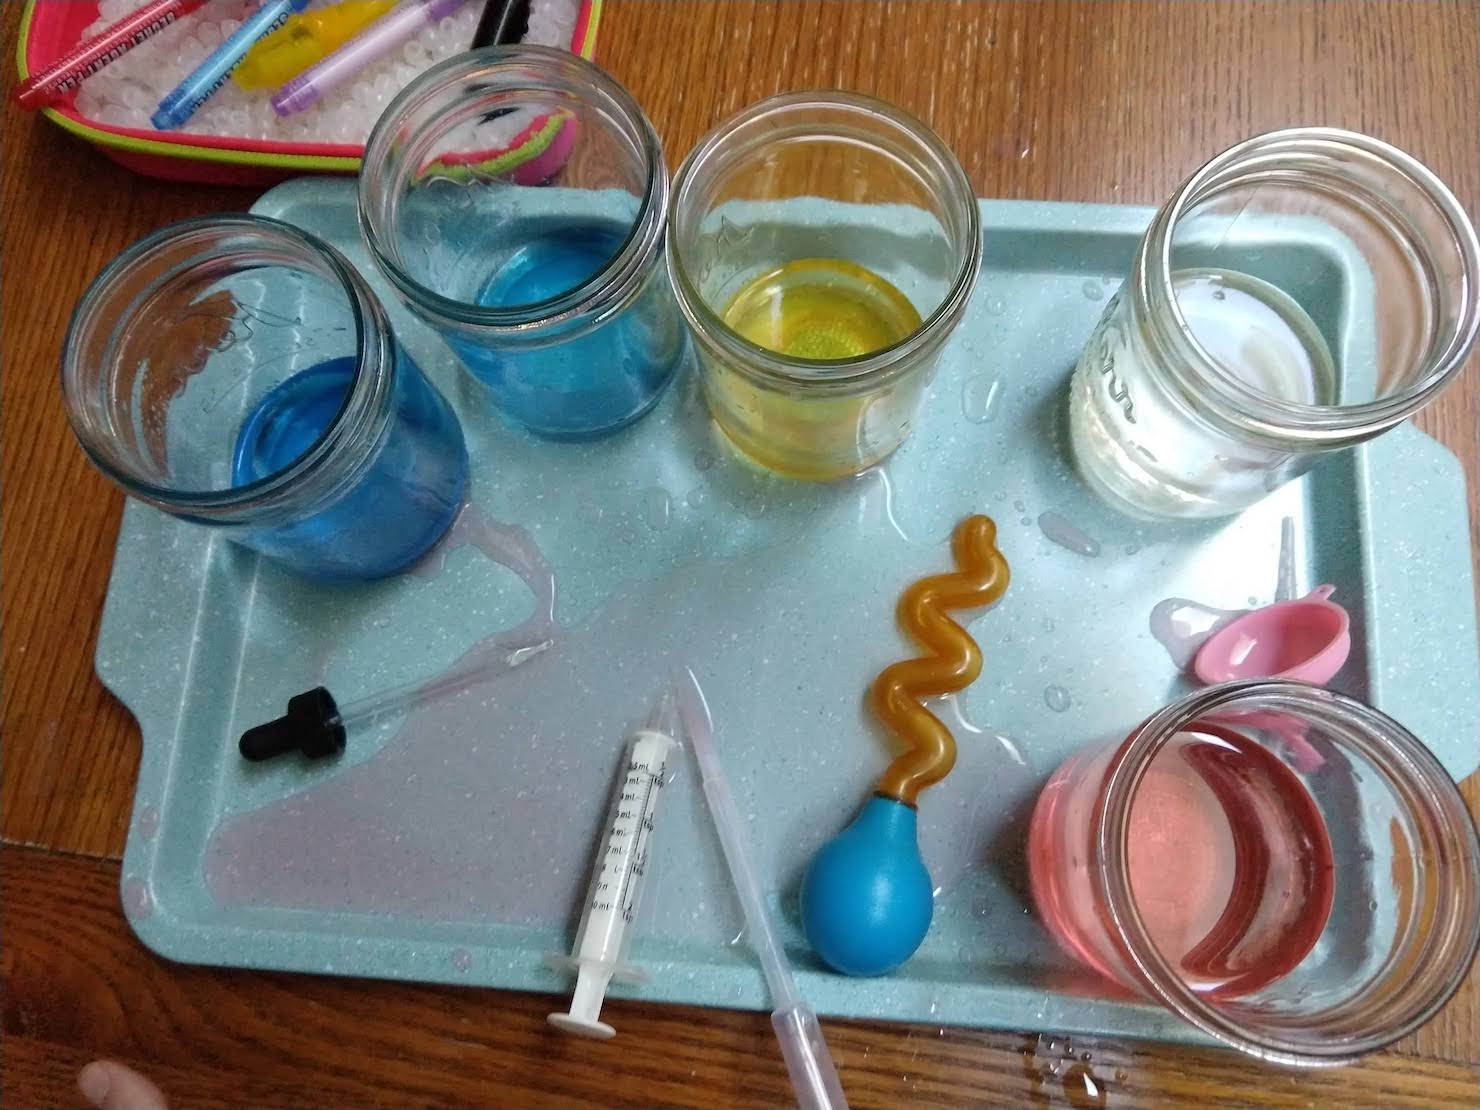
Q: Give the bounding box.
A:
[667,89,981,391]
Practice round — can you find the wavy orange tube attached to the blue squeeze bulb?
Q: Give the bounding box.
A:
[872,515,1009,805]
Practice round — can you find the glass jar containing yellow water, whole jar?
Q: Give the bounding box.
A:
[669,92,981,480]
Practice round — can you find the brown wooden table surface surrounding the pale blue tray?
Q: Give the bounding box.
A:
[0,0,1480,1110]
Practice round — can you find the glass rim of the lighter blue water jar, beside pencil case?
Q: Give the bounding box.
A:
[358,44,667,339]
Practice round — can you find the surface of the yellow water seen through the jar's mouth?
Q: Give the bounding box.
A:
[724,258,921,361]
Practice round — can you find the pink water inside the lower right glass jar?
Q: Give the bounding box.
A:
[1029,722,1333,998]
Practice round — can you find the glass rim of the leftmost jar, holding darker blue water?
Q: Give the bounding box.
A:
[61,213,395,522]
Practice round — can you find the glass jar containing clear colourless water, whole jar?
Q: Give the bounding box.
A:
[1070,127,1480,517]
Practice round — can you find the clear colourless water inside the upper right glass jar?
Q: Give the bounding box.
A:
[1070,268,1336,517]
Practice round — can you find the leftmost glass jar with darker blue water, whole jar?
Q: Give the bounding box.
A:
[62,215,468,580]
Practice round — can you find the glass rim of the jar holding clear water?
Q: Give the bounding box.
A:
[1134,127,1480,447]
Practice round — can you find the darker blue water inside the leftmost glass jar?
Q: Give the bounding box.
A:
[232,352,468,580]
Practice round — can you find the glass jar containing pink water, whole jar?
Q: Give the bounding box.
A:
[1029,679,1480,1064]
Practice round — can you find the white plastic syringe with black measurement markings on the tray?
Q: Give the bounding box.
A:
[546,694,678,1040]
